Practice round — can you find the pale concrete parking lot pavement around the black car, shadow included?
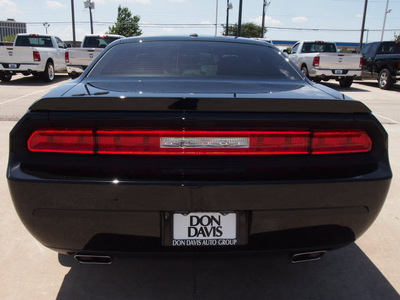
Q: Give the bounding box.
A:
[0,75,400,299]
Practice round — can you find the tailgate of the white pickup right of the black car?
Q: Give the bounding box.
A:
[318,53,361,70]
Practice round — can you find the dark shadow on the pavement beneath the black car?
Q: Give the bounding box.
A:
[57,244,400,300]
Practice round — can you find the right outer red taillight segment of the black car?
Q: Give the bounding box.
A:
[311,130,372,154]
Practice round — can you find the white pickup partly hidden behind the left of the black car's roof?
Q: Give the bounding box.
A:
[67,34,124,78]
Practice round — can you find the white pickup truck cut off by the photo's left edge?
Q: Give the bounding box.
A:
[0,34,68,82]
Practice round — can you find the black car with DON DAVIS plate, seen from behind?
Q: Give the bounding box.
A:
[7,37,392,262]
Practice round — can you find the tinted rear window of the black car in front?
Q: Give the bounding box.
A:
[89,41,301,80]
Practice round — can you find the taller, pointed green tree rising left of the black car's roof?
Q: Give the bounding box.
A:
[108,5,142,37]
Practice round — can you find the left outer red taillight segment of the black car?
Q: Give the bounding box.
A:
[28,130,94,153]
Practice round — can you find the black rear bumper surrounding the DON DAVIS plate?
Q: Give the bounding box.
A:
[7,157,391,253]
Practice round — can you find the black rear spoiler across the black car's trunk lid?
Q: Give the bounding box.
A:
[30,96,371,113]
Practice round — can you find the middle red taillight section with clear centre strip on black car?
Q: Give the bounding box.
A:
[97,130,310,155]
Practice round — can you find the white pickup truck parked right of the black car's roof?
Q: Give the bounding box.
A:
[288,41,363,88]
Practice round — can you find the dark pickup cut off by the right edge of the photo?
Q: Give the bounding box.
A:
[360,42,400,90]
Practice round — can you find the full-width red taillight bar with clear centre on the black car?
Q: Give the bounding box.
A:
[28,130,372,155]
